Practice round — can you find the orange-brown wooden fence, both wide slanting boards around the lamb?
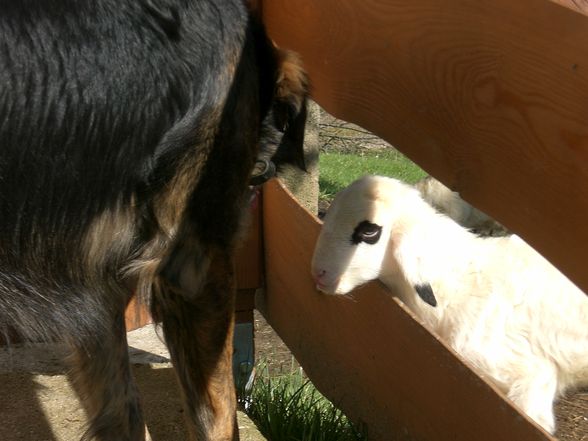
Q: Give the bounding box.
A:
[256,0,588,441]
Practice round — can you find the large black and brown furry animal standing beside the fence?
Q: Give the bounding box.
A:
[0,0,306,441]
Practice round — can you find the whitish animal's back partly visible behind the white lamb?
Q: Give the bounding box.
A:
[415,176,509,236]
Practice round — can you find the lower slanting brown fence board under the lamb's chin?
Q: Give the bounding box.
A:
[262,180,552,441]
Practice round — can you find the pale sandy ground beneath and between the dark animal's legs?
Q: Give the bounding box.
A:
[0,325,265,441]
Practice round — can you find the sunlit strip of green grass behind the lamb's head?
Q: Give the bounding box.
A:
[319,149,427,199]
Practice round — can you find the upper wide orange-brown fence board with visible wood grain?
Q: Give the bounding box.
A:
[262,0,588,291]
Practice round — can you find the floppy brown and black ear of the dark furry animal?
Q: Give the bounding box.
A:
[272,48,308,171]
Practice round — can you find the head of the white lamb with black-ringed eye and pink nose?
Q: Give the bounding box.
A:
[312,176,420,294]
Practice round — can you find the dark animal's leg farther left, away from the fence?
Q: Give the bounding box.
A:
[69,305,145,441]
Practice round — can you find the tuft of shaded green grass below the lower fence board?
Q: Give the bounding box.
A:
[241,368,367,441]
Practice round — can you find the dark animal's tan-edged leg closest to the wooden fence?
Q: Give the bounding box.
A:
[152,248,239,441]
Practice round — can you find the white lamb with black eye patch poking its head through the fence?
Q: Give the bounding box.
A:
[312,176,588,433]
